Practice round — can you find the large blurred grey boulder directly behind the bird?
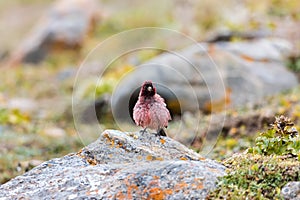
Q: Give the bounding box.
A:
[112,39,297,119]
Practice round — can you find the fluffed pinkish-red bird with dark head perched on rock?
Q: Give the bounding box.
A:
[133,81,171,136]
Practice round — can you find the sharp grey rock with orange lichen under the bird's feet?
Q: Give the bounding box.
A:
[0,130,225,199]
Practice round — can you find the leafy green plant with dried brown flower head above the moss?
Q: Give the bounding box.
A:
[248,115,300,159]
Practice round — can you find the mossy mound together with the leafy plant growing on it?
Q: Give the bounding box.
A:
[207,116,300,199]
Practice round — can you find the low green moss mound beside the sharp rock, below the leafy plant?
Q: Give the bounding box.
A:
[208,154,300,199]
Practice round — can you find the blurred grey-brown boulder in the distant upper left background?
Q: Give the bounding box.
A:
[9,0,99,65]
